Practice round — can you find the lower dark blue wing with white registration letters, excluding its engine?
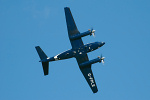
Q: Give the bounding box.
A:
[76,54,98,93]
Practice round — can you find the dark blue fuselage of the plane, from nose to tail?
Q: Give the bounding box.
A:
[46,42,105,61]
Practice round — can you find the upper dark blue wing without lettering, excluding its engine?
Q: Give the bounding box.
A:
[64,7,83,48]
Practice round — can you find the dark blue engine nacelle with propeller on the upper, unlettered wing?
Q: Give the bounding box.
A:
[70,29,95,40]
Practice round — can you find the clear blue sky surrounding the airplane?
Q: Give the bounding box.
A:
[0,0,150,100]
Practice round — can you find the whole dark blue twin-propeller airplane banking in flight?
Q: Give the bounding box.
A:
[35,7,105,93]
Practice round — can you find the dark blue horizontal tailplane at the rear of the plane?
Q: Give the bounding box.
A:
[35,46,49,75]
